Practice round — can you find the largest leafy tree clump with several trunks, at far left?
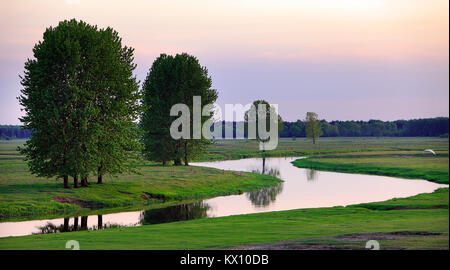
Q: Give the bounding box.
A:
[19,20,140,188]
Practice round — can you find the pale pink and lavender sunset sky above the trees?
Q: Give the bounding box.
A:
[0,0,449,124]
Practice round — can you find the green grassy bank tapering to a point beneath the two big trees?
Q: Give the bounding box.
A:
[0,141,280,221]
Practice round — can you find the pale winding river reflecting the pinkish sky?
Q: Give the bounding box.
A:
[0,157,448,237]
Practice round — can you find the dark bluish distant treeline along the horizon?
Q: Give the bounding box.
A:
[0,117,449,140]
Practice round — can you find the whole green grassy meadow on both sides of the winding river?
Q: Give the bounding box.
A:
[0,138,449,249]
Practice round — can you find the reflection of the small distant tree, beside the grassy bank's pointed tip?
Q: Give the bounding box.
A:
[245,158,283,207]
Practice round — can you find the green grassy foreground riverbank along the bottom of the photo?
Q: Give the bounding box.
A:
[0,189,449,250]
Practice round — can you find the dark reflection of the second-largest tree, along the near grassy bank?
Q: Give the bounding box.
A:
[140,201,210,225]
